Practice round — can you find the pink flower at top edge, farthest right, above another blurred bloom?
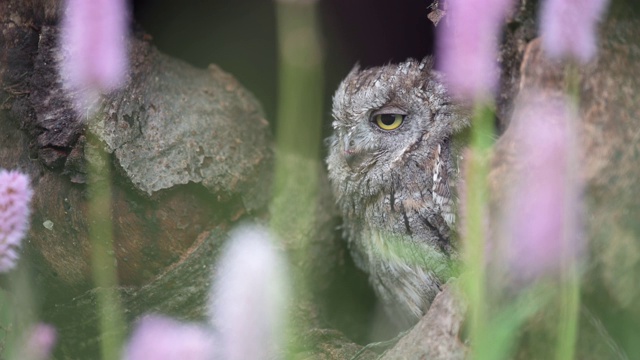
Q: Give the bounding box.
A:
[540,0,609,63]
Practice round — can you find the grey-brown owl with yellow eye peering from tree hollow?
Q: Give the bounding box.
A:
[326,58,469,328]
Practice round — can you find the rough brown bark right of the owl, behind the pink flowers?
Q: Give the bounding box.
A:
[490,14,640,359]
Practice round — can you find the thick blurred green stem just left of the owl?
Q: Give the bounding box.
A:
[270,0,324,356]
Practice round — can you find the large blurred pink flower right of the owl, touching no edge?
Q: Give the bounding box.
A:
[500,95,583,281]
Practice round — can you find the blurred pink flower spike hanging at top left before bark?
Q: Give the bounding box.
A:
[60,0,128,112]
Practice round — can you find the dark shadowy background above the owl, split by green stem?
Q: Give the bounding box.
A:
[133,0,434,134]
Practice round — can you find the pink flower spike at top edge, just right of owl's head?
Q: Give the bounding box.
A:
[437,0,512,100]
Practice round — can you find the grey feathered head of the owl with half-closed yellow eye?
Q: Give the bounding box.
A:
[327,58,468,205]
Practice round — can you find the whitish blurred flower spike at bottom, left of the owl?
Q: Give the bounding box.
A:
[210,226,290,360]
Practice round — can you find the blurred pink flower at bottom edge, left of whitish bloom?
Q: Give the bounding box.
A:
[123,315,215,360]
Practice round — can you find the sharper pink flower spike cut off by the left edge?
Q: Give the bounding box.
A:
[0,169,33,272]
